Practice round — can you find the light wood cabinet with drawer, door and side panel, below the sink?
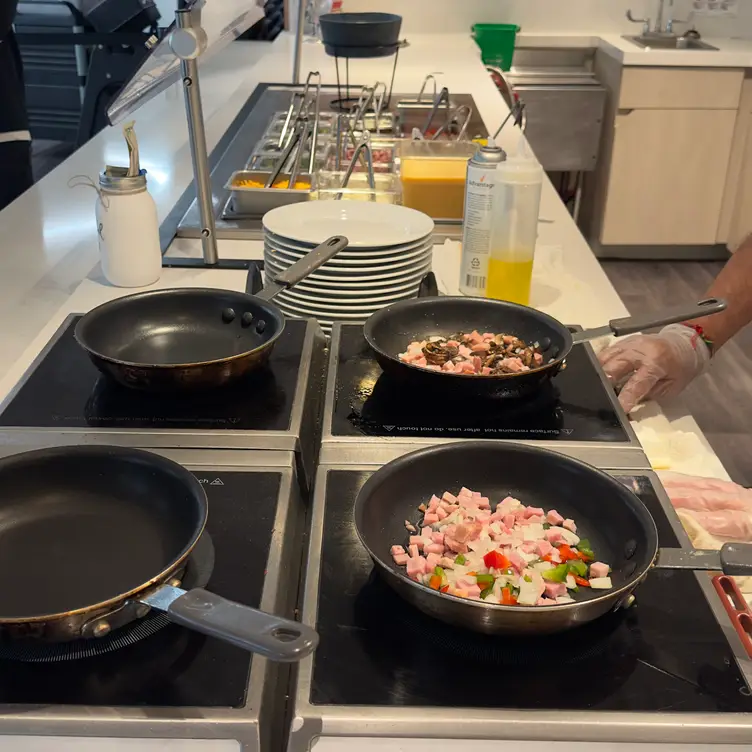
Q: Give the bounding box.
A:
[580,56,752,250]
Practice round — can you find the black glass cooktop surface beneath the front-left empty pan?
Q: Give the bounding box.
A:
[0,471,280,708]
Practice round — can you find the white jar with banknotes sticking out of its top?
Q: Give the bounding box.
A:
[95,122,162,287]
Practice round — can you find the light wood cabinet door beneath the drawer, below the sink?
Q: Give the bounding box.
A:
[601,110,736,245]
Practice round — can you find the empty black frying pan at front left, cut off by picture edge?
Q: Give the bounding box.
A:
[0,446,318,661]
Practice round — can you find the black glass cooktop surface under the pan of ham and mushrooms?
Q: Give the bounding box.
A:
[332,325,629,443]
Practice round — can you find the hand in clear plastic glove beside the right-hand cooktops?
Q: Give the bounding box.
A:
[598,324,711,413]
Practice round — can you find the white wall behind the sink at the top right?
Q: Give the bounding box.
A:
[344,0,752,38]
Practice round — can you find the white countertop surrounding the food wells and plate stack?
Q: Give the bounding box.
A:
[0,29,722,474]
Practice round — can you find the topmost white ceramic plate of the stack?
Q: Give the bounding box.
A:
[262,201,434,248]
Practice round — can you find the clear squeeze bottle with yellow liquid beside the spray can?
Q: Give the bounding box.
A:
[486,137,543,305]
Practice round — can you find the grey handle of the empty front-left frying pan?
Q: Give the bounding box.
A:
[139,585,319,663]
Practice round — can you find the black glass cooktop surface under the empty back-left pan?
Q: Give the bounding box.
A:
[0,317,306,431]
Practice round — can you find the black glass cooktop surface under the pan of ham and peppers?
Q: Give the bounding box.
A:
[310,470,752,712]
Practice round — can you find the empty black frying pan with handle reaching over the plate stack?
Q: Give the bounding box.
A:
[75,236,347,391]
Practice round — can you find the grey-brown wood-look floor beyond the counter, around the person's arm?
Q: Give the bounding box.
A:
[603,261,752,486]
